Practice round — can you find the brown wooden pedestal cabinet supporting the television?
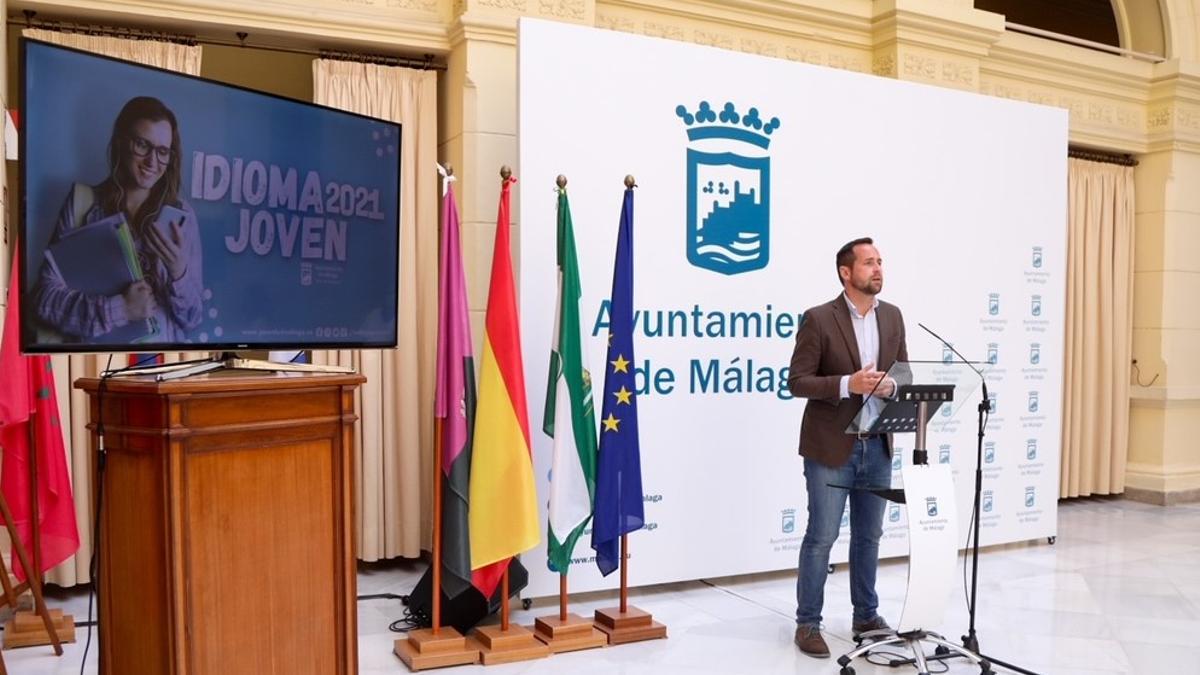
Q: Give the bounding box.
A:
[76,371,365,675]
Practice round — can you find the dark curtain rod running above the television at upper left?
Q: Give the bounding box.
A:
[8,10,446,71]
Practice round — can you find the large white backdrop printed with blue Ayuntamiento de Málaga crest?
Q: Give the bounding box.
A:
[517,19,1067,597]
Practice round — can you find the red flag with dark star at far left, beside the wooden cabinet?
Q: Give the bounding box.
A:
[0,252,79,581]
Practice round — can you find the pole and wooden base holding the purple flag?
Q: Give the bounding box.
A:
[392,165,479,673]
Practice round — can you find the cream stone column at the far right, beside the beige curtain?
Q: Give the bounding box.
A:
[1126,60,1200,504]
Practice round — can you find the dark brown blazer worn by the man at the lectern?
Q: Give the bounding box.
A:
[787,293,908,467]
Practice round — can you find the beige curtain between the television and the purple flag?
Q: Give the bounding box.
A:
[313,59,438,561]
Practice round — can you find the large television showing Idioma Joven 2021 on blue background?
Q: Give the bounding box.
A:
[20,40,401,352]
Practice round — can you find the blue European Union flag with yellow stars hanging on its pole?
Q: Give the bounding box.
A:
[592,187,646,575]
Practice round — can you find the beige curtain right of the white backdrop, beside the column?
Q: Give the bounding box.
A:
[1060,159,1134,497]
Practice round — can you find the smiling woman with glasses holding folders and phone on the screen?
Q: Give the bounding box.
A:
[34,96,204,345]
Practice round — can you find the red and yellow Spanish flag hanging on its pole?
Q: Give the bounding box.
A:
[469,171,541,597]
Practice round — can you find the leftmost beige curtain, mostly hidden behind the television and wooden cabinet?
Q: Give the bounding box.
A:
[15,29,200,586]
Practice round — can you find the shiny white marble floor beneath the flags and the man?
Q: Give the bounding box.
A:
[4,500,1200,675]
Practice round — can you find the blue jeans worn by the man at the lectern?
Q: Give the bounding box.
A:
[796,436,892,625]
